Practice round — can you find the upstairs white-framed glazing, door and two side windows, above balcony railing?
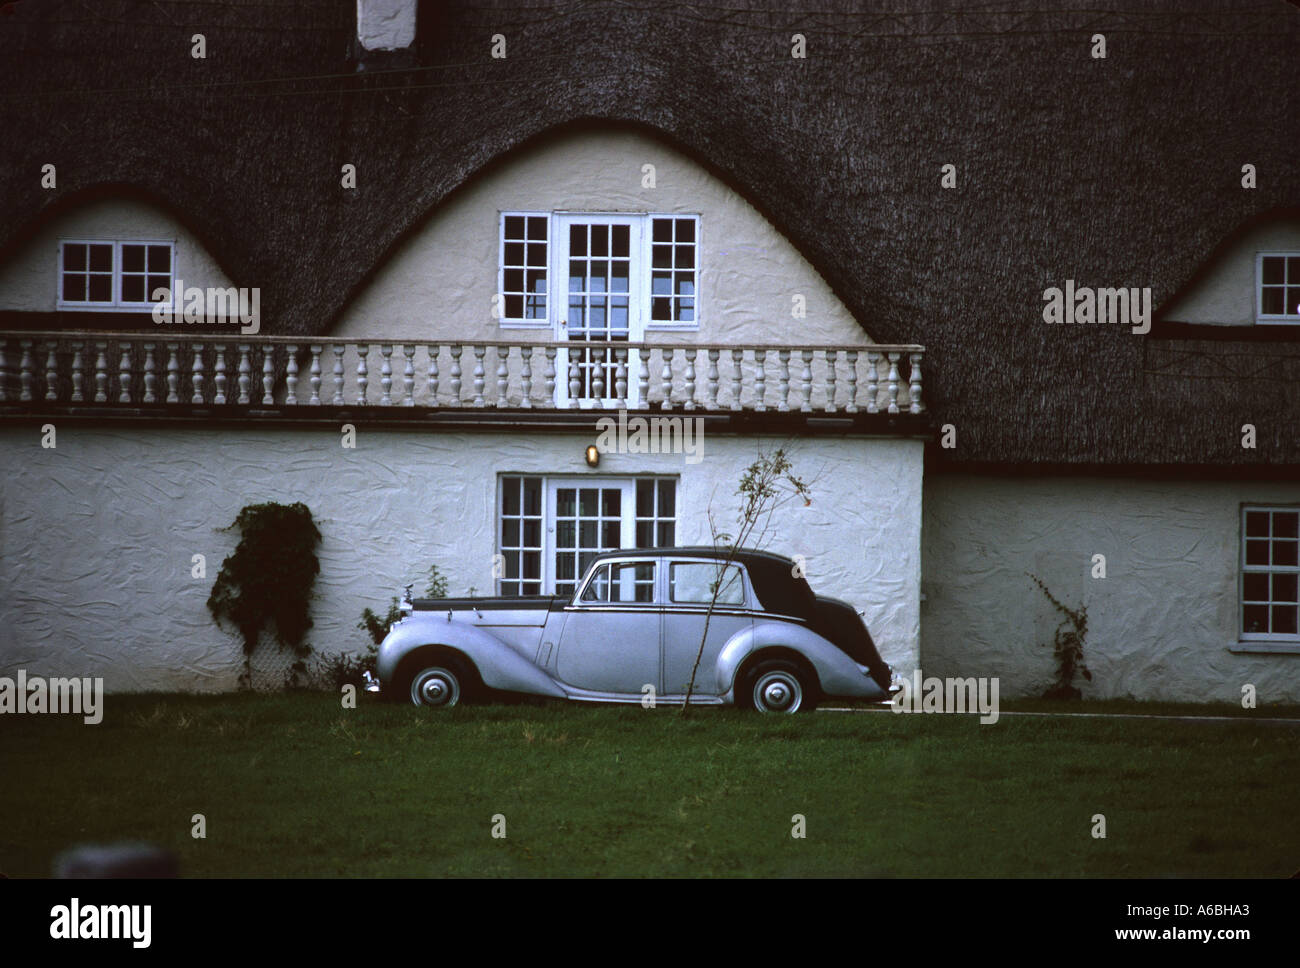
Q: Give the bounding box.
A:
[497,212,699,340]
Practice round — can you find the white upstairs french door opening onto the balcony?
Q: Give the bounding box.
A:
[551,213,645,408]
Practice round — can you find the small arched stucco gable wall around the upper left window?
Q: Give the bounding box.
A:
[0,199,234,312]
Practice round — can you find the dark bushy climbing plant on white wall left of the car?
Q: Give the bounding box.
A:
[208,503,321,686]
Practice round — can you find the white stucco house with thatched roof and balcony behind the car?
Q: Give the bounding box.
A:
[0,0,1300,704]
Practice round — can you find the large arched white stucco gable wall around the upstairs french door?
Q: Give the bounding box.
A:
[330,130,870,346]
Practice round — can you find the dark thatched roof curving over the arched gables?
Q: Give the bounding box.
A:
[0,0,1300,466]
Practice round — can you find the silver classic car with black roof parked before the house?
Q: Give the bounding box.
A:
[377,547,892,712]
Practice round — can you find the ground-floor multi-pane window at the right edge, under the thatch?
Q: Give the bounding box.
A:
[1242,507,1300,638]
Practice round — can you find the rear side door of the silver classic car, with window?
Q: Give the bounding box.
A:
[663,559,754,696]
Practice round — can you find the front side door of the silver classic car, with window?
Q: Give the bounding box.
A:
[555,559,662,696]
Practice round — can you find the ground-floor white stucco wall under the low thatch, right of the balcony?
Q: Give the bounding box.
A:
[922,474,1300,703]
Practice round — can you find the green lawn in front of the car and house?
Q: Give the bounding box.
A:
[0,694,1300,877]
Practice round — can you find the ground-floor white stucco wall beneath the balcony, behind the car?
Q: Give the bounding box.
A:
[0,424,922,691]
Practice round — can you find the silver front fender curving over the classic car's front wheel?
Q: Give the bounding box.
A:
[376,612,566,699]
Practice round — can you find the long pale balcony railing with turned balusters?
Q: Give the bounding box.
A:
[0,331,924,413]
